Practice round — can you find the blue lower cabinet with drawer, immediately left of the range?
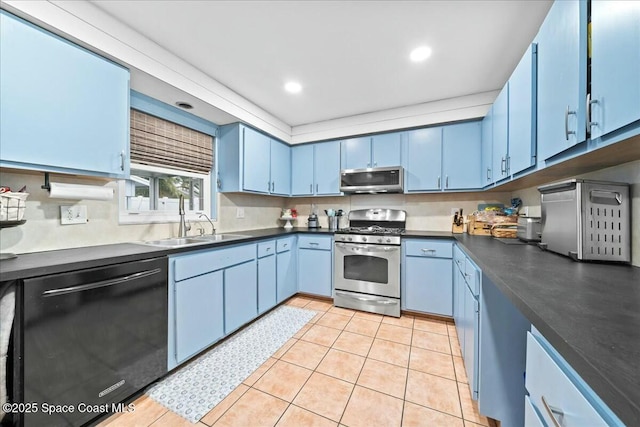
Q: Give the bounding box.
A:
[298,235,333,297]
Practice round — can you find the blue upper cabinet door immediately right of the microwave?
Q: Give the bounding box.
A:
[406,127,442,191]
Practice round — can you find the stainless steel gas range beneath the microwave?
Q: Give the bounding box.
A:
[333,209,407,317]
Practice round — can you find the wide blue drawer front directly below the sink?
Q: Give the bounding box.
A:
[173,243,256,282]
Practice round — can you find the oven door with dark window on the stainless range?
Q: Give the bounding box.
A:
[334,243,400,298]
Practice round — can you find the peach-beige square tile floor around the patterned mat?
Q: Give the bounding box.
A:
[100,296,491,427]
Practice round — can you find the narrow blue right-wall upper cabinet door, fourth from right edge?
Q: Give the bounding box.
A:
[491,83,509,182]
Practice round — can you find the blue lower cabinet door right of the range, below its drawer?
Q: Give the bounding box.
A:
[404,257,453,316]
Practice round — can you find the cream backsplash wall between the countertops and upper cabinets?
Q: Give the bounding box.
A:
[0,161,640,266]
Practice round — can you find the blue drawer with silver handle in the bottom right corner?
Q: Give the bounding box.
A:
[526,332,607,427]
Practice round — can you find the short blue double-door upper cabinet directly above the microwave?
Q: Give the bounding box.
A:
[342,132,402,169]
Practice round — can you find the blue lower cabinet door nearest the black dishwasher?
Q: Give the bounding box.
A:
[175,271,224,362]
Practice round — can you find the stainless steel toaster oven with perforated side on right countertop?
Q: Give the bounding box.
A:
[538,179,631,263]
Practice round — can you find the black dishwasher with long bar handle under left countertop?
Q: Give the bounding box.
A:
[20,258,167,427]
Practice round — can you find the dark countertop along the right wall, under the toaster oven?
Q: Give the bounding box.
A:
[455,234,640,426]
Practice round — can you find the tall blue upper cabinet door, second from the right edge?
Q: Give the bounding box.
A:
[536,0,588,164]
